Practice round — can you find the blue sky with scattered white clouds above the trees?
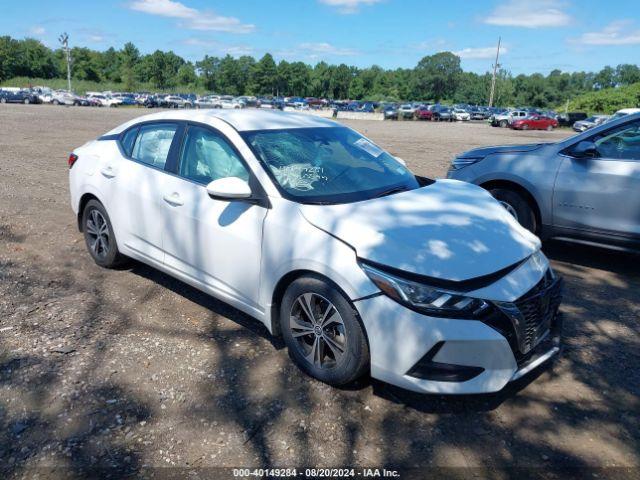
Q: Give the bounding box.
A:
[0,0,640,75]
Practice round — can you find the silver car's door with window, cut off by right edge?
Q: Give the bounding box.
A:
[553,120,640,240]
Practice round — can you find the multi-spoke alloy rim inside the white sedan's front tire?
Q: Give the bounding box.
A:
[289,293,347,369]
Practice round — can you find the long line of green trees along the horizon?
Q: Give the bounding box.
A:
[0,36,640,108]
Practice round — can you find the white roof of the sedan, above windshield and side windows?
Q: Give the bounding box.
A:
[107,109,342,135]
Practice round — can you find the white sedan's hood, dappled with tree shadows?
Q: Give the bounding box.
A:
[300,180,540,281]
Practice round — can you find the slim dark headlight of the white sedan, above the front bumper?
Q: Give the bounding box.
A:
[360,263,489,319]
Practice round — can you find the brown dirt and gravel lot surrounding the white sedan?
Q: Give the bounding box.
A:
[0,105,640,478]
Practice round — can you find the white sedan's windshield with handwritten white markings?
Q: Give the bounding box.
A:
[243,127,420,203]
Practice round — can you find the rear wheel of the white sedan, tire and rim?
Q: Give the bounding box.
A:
[82,200,126,268]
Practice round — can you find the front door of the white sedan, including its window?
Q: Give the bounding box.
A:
[163,125,267,309]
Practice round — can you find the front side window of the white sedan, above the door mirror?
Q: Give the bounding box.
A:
[179,126,249,185]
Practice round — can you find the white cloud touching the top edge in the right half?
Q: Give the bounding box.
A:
[484,0,571,28]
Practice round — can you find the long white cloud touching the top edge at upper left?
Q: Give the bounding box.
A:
[129,0,255,33]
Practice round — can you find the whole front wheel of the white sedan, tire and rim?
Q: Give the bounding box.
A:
[280,276,369,386]
